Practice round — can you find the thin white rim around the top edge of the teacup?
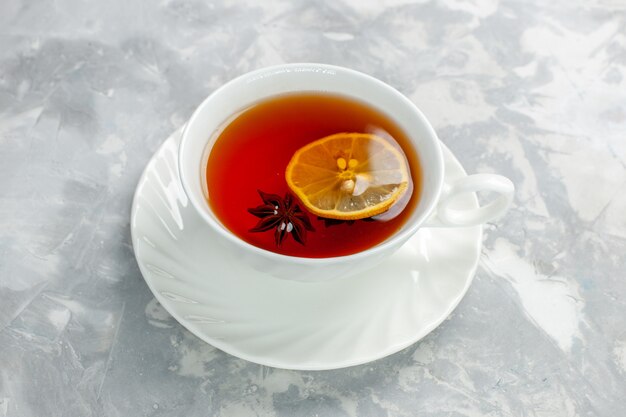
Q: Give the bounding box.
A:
[178,62,444,266]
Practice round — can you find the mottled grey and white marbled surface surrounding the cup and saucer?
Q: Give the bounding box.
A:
[0,0,626,417]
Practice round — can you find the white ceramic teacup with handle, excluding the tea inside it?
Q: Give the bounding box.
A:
[179,64,514,282]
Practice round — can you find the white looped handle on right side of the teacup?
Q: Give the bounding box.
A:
[426,174,515,227]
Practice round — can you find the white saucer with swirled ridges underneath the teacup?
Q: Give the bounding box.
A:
[131,130,482,370]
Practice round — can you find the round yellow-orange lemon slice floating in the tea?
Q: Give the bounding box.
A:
[285,133,410,220]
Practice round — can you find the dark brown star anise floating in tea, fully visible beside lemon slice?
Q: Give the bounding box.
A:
[248,190,315,247]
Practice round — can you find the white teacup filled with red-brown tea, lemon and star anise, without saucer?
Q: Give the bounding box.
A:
[178,64,514,282]
